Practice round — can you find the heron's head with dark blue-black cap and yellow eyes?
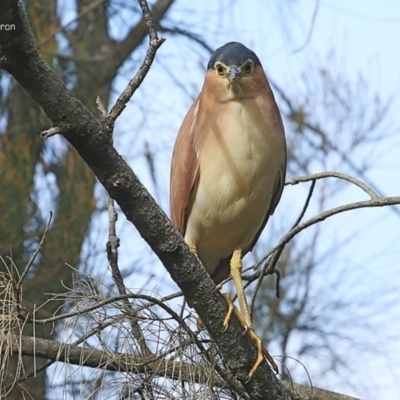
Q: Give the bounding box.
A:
[205,42,265,101]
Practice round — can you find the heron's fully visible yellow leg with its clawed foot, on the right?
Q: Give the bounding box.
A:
[224,250,279,379]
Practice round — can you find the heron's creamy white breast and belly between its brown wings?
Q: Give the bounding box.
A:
[185,101,282,274]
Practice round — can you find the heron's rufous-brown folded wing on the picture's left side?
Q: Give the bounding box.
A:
[170,96,200,234]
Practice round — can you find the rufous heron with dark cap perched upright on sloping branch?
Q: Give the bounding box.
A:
[170,42,286,377]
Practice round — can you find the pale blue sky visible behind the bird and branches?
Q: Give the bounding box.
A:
[53,0,400,400]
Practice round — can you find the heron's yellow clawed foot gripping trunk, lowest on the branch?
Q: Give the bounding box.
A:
[223,293,279,381]
